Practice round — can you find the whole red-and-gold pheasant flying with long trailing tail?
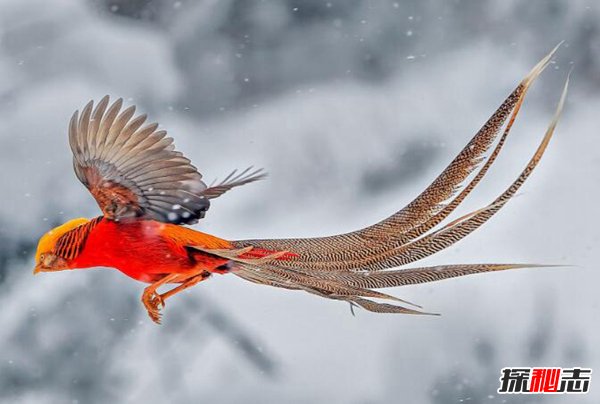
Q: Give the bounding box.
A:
[34,48,568,323]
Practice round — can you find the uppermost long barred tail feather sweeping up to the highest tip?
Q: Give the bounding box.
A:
[234,44,560,269]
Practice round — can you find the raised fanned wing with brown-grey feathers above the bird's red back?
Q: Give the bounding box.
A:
[69,96,262,224]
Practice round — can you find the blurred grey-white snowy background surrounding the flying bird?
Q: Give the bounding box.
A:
[0,0,600,404]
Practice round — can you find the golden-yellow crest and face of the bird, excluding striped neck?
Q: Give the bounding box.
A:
[33,218,89,274]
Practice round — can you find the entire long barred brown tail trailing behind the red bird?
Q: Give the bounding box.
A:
[203,44,569,314]
